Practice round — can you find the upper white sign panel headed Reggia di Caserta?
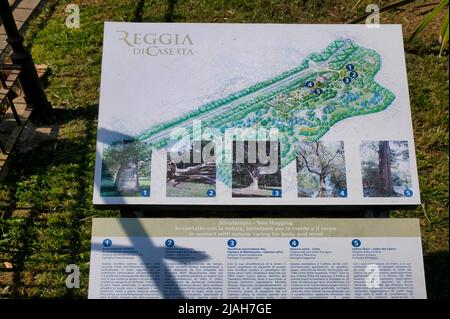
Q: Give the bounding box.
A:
[94,23,420,206]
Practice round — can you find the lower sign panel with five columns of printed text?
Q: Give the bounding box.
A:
[89,218,426,299]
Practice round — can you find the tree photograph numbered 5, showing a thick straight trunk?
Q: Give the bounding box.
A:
[360,141,412,197]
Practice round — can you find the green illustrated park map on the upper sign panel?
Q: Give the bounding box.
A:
[101,39,395,195]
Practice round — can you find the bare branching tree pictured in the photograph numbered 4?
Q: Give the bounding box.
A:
[297,141,345,197]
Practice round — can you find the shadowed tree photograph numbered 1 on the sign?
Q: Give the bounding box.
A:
[100,140,151,197]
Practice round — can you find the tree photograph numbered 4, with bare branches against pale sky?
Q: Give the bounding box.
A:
[296,141,347,197]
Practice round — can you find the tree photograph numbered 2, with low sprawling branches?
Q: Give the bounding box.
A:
[166,141,216,197]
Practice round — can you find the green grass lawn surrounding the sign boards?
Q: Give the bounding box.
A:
[0,0,449,298]
